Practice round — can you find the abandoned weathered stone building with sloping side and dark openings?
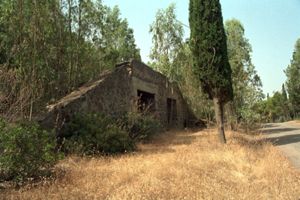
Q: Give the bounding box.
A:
[41,60,196,133]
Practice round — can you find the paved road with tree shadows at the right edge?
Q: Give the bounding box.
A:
[262,122,300,169]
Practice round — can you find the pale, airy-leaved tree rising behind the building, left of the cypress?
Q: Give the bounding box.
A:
[150,4,184,82]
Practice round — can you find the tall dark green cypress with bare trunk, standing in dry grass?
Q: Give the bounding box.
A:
[189,0,233,143]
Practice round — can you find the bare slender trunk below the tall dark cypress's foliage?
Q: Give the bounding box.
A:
[213,97,226,144]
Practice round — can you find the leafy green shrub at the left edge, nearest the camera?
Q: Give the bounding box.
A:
[0,119,58,182]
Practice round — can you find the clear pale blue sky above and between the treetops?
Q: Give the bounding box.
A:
[103,0,300,94]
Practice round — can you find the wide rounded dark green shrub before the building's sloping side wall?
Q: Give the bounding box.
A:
[62,114,135,155]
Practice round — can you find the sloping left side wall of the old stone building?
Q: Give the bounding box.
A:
[41,67,132,132]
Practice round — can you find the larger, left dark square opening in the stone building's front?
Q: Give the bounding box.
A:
[137,90,155,112]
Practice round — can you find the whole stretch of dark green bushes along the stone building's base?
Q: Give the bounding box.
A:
[62,113,160,155]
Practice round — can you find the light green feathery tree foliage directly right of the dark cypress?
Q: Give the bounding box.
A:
[225,19,263,109]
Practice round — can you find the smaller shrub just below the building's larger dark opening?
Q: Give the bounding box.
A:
[118,113,161,141]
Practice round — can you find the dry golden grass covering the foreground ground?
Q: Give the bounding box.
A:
[0,130,300,200]
